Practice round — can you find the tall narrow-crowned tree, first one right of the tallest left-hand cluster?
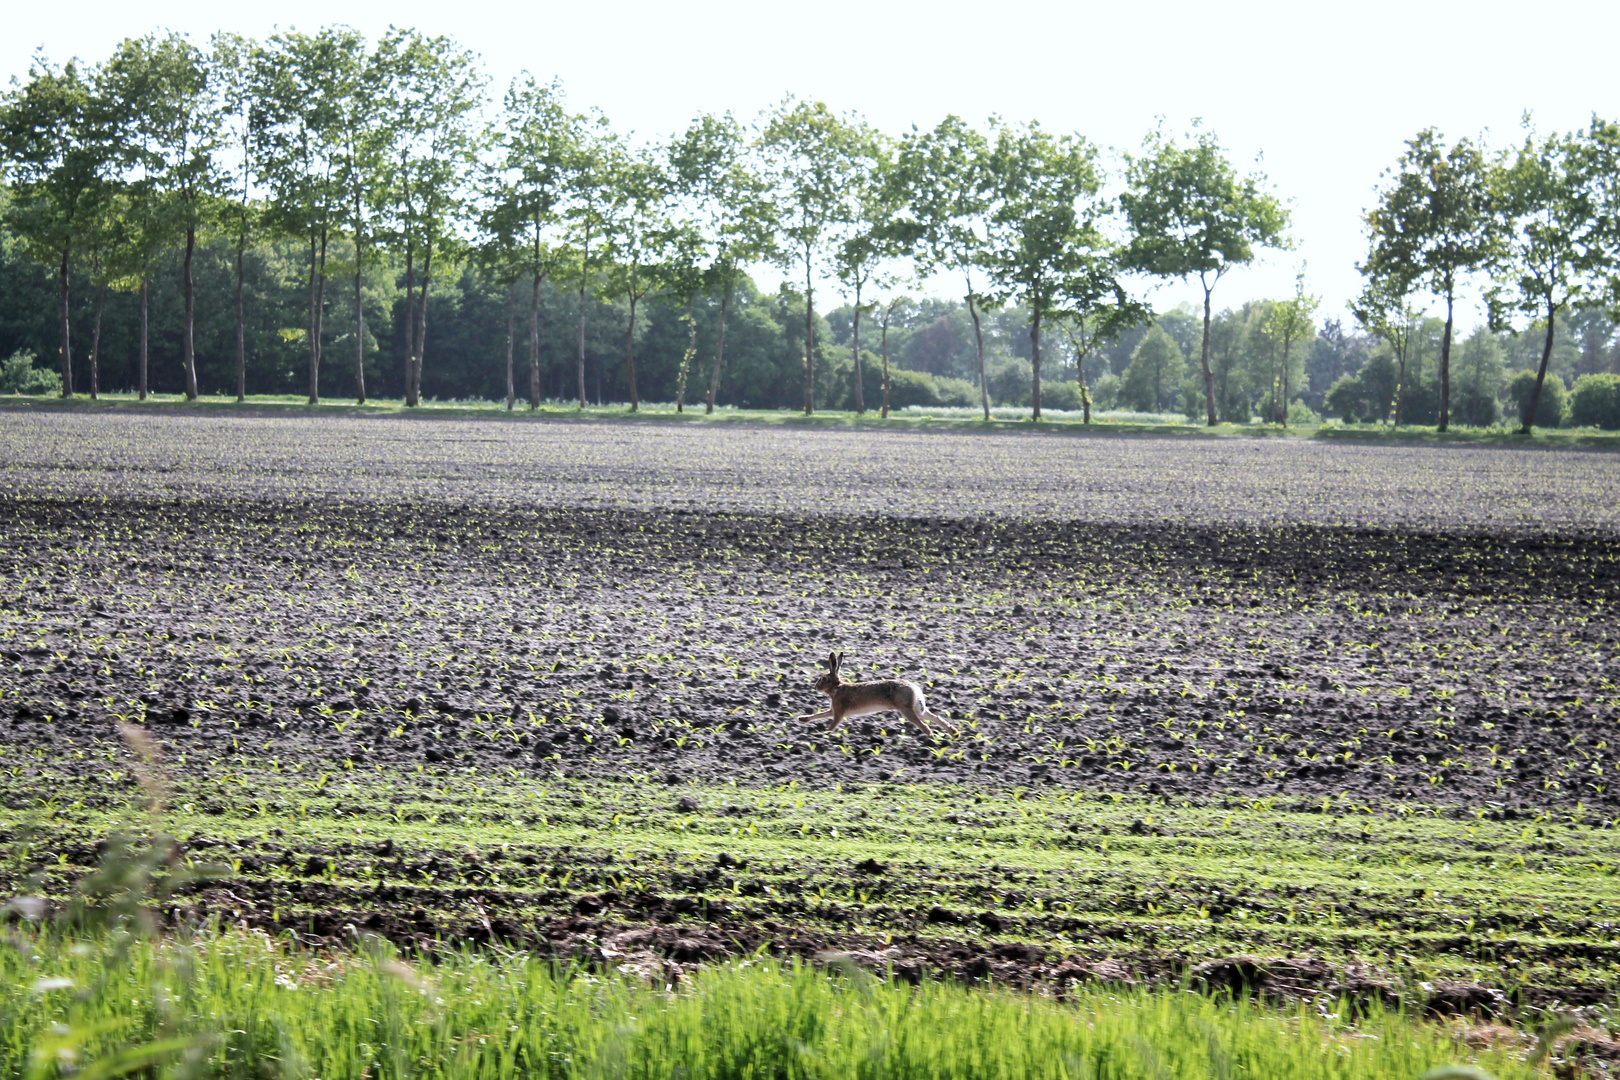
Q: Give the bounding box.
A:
[484,71,582,410]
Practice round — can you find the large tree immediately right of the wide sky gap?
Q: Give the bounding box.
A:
[1358,135,1495,431]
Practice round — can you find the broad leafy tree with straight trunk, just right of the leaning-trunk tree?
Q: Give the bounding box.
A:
[983,123,1128,419]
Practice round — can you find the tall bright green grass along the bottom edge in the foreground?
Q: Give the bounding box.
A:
[0,928,1534,1080]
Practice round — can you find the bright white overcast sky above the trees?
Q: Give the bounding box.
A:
[0,0,1620,331]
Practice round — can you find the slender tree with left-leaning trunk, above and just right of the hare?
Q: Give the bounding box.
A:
[897,117,990,419]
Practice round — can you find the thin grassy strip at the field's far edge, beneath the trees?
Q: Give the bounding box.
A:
[0,393,1620,450]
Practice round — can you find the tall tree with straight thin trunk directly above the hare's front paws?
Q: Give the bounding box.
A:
[761,97,860,416]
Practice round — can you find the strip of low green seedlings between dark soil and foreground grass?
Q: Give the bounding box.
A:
[0,764,1620,1002]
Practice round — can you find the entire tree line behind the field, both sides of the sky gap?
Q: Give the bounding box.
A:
[9,26,1620,429]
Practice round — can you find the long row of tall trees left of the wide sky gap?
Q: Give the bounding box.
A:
[0,28,1286,419]
